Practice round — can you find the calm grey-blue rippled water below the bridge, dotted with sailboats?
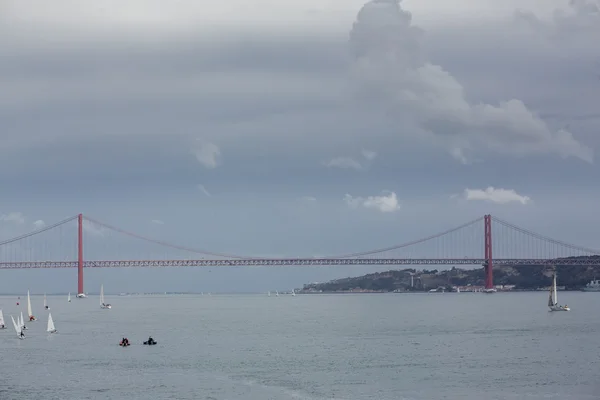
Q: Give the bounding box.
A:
[0,292,600,400]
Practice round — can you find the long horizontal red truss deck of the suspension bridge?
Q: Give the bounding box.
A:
[0,256,600,269]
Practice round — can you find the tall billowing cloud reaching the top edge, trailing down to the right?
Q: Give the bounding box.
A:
[350,0,593,162]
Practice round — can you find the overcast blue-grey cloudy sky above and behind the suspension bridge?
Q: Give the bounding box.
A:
[0,0,600,291]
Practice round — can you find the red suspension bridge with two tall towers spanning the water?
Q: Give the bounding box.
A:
[0,214,600,294]
